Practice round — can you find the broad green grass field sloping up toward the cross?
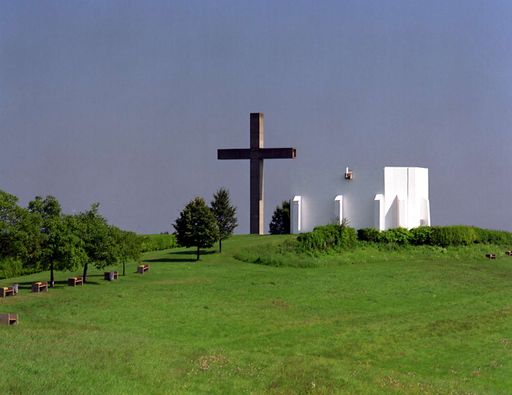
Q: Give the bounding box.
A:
[0,236,512,394]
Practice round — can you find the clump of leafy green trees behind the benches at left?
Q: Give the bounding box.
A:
[0,191,142,280]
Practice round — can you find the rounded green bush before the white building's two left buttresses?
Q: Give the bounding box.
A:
[297,224,356,252]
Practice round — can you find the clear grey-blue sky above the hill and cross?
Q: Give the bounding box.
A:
[0,0,512,233]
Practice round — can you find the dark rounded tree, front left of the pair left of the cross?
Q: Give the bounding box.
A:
[173,197,219,260]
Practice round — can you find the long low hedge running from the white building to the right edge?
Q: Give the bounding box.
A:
[357,225,512,247]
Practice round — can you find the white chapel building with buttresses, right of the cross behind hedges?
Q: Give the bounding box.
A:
[290,167,430,233]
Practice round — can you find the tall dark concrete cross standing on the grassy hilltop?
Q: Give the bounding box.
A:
[217,112,296,235]
